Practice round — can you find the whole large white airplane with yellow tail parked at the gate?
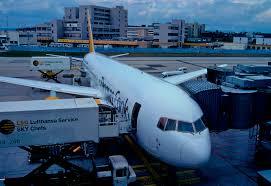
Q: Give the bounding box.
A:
[0,12,215,168]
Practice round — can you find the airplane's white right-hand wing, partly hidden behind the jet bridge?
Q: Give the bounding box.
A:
[163,64,230,85]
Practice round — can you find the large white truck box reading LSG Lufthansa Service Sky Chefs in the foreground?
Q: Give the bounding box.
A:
[0,98,99,148]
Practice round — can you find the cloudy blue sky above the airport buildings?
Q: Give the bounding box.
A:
[0,0,271,32]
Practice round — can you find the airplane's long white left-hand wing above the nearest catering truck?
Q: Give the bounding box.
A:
[0,76,103,98]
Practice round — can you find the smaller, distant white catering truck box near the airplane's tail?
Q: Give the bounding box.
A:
[30,56,71,71]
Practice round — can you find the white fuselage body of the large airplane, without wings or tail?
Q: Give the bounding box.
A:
[84,53,211,167]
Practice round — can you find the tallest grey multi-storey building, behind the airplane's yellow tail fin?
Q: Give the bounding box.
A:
[63,5,128,40]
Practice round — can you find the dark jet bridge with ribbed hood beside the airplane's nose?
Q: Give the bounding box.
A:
[180,65,271,132]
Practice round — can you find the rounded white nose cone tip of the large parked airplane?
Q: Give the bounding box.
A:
[180,140,211,168]
